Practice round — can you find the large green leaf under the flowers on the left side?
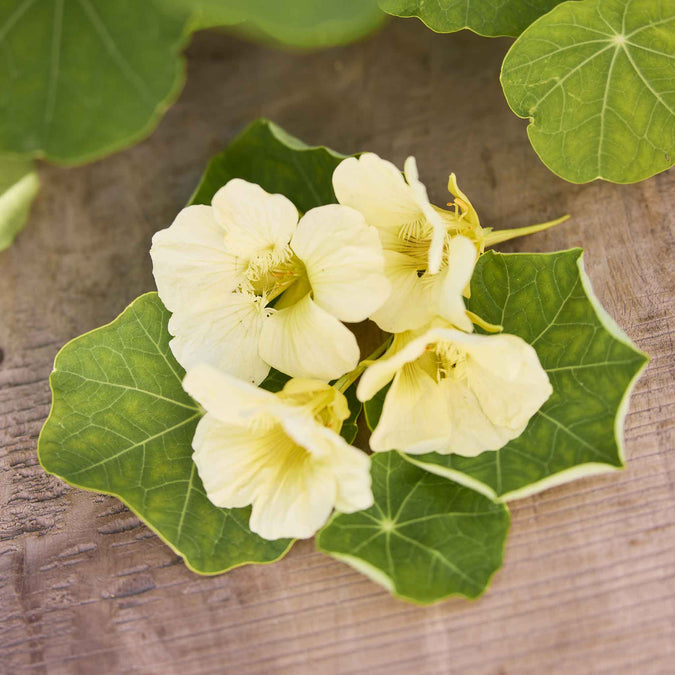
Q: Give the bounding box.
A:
[38,293,291,574]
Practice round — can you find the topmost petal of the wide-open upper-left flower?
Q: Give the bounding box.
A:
[211,178,298,260]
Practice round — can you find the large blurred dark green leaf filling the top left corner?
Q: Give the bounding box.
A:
[0,0,187,164]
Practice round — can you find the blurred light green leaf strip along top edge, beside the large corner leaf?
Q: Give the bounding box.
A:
[169,0,384,49]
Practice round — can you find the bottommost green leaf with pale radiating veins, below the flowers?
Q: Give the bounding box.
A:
[316,452,509,604]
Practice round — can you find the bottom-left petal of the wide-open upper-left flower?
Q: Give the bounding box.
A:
[169,293,269,384]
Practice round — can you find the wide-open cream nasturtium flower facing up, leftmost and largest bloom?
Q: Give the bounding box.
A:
[150,179,389,384]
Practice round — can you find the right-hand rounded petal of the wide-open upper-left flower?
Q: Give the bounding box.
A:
[291,204,389,323]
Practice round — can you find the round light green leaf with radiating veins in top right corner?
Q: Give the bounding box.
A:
[501,0,675,183]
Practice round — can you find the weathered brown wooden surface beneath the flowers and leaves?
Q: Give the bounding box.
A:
[0,21,675,675]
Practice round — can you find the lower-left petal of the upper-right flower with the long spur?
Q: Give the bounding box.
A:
[370,250,441,333]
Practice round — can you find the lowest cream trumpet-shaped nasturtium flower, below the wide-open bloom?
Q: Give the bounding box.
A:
[183,364,373,539]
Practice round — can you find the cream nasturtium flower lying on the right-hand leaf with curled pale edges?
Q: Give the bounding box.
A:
[357,325,553,457]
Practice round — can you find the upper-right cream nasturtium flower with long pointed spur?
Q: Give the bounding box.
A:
[333,153,565,333]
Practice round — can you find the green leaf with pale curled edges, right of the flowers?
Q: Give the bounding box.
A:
[366,249,647,500]
